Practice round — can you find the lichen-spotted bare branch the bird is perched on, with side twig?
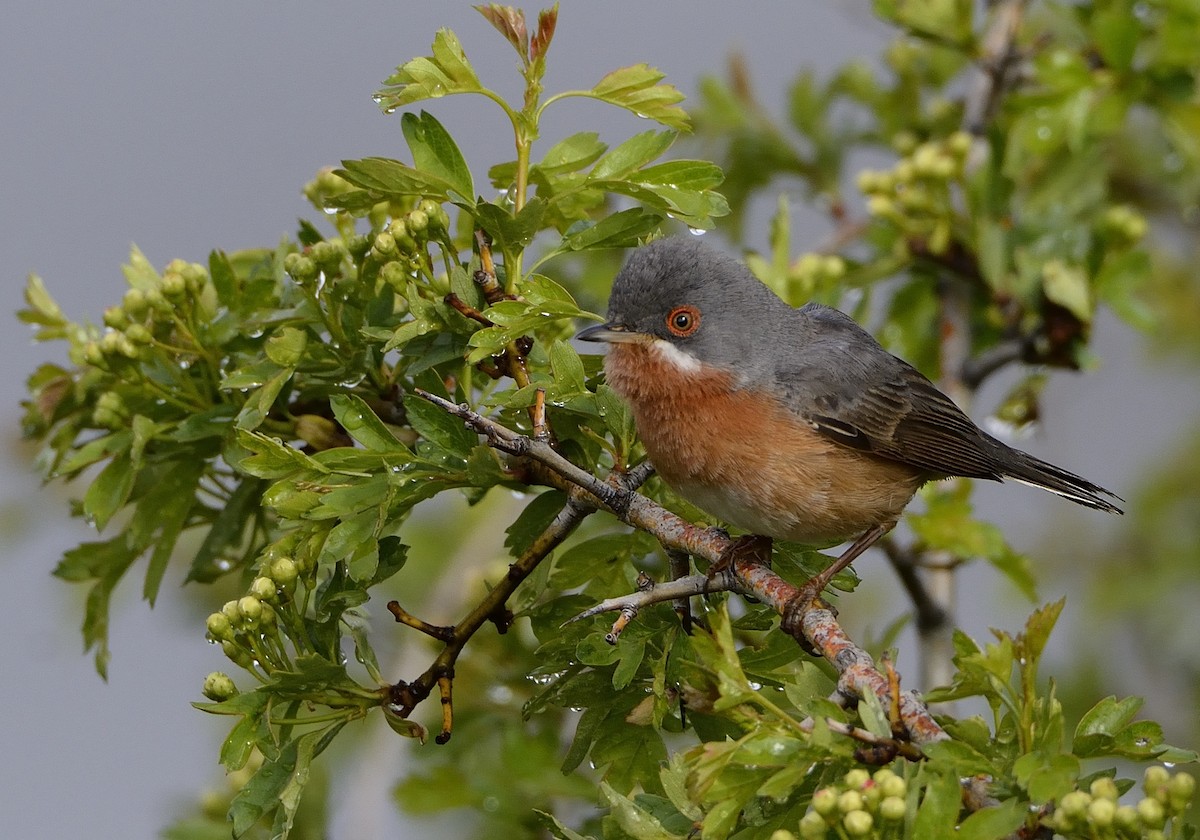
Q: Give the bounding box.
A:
[418,391,949,745]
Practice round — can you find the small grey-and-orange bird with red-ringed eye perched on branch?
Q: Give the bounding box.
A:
[576,236,1123,618]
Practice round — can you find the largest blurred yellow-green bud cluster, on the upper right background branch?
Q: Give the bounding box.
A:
[858,131,973,253]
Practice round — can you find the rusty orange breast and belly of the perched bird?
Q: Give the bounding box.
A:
[605,344,925,544]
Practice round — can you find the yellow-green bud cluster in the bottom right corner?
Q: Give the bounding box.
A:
[1045,764,1196,840]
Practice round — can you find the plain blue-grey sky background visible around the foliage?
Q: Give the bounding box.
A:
[0,0,1200,838]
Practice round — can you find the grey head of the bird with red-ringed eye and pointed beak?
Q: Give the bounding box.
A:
[578,236,794,374]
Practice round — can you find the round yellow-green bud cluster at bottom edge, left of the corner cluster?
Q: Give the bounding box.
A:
[799,767,908,840]
